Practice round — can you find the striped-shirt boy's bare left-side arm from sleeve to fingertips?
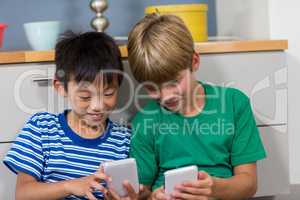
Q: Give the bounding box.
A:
[16,172,108,200]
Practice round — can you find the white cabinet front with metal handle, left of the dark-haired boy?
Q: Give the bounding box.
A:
[0,64,62,142]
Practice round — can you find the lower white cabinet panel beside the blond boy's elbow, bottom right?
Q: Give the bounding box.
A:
[256,126,289,196]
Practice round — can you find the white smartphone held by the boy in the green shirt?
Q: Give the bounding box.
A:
[164,165,198,195]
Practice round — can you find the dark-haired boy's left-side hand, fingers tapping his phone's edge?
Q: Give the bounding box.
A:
[65,168,110,200]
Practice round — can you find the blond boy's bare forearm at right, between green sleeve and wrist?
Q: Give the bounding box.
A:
[212,173,257,200]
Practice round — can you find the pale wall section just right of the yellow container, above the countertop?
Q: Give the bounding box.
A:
[216,0,269,39]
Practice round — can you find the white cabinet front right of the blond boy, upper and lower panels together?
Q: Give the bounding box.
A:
[196,51,289,196]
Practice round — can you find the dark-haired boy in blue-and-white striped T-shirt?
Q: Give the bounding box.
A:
[4,32,131,200]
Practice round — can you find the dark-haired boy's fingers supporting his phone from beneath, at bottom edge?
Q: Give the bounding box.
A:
[105,181,145,200]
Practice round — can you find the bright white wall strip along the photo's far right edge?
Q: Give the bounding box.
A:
[269,0,300,184]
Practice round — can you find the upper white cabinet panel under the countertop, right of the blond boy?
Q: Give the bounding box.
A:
[196,52,287,125]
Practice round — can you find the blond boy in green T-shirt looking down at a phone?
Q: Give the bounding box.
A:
[128,14,266,200]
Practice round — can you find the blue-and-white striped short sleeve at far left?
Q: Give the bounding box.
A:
[3,115,44,180]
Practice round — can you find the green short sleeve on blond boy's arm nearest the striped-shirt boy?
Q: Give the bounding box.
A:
[130,111,158,186]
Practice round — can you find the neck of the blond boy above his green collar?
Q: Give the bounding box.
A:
[182,80,205,117]
